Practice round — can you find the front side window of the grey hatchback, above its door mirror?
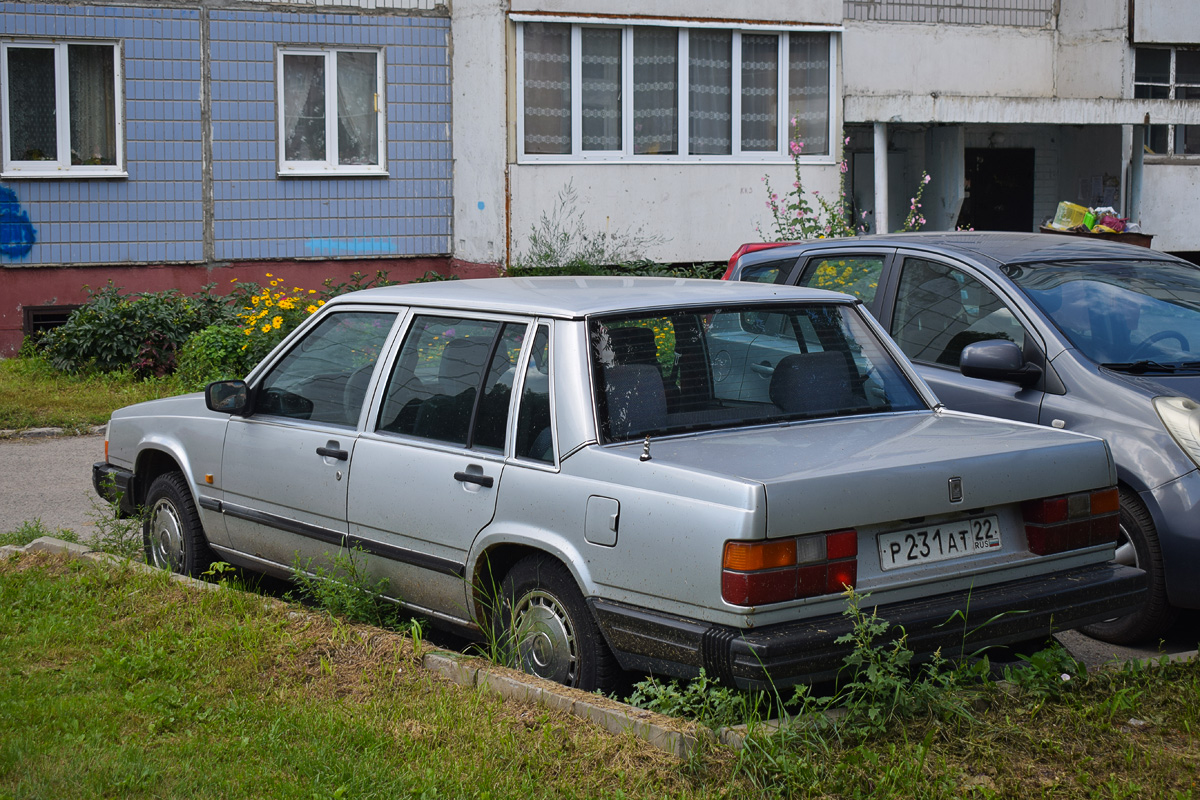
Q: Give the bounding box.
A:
[892,258,1025,368]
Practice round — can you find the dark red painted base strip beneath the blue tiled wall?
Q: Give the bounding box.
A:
[0,257,499,356]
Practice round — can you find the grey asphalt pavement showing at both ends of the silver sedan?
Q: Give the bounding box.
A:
[0,434,1200,667]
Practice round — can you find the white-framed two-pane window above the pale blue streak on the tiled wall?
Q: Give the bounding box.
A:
[278,50,385,175]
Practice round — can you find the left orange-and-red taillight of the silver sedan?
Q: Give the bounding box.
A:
[721,530,858,606]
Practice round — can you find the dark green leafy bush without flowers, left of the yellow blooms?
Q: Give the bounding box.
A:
[40,283,233,377]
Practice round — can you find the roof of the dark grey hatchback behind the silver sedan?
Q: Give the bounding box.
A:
[754,230,1180,264]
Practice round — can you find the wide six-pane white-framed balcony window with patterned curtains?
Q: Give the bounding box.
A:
[517,22,833,161]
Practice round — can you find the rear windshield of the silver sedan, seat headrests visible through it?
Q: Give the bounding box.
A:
[589,303,928,441]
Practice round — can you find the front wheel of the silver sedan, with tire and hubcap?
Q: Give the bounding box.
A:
[142,473,216,578]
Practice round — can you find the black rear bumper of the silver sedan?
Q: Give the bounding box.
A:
[590,563,1146,688]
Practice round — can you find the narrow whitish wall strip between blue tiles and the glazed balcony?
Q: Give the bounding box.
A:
[450,0,508,264]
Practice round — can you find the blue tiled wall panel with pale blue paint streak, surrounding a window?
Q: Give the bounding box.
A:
[210,11,452,260]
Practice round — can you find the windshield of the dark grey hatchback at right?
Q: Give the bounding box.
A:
[1004,261,1200,372]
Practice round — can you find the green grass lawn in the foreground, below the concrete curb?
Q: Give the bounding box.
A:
[0,554,1200,800]
